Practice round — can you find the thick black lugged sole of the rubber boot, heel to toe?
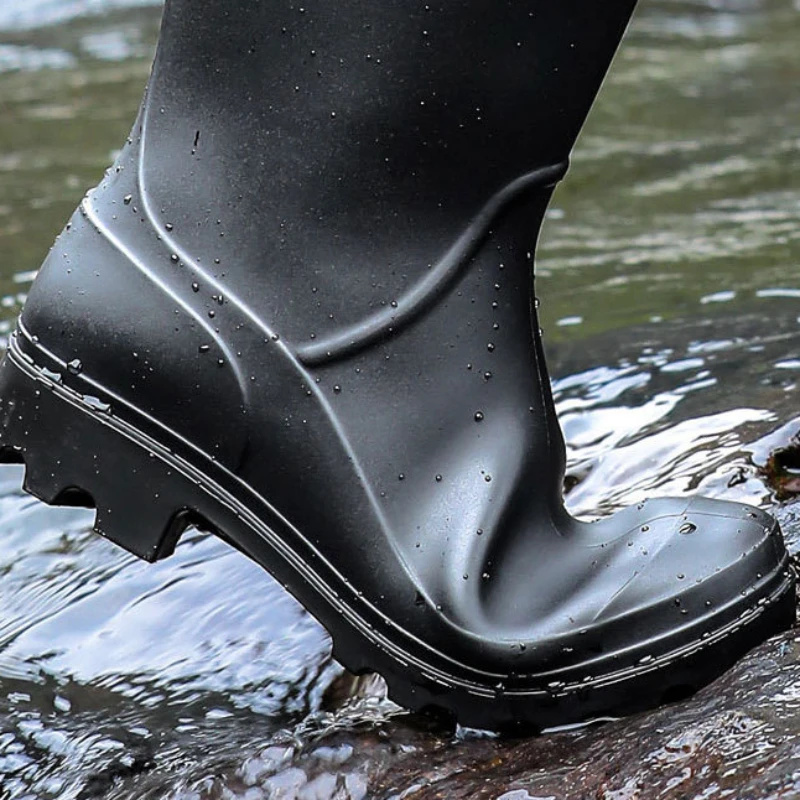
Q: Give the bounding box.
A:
[0,334,795,730]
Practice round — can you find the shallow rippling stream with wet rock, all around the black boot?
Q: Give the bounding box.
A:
[0,0,800,800]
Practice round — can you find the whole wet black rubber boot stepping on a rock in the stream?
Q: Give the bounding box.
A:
[0,0,794,729]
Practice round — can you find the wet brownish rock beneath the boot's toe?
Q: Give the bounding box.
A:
[252,631,800,800]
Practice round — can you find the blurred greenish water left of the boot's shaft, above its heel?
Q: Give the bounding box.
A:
[0,8,160,320]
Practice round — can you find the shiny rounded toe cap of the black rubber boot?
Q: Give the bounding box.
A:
[564,498,787,672]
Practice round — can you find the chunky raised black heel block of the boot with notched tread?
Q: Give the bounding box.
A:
[0,352,189,561]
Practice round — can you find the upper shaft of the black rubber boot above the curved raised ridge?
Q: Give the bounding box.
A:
[140,0,634,341]
